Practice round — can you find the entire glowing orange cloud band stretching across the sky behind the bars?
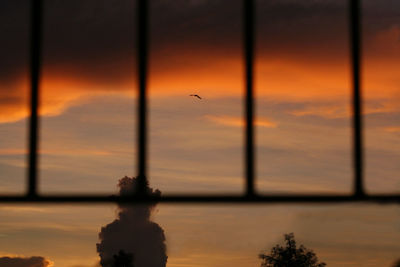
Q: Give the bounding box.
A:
[0,23,400,123]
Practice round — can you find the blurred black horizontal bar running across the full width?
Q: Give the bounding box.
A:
[0,194,400,204]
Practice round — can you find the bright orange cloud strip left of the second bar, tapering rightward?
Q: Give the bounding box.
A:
[0,75,135,123]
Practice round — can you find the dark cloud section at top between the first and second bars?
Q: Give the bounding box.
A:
[44,0,136,83]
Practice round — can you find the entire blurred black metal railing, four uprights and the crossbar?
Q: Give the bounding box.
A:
[0,0,400,203]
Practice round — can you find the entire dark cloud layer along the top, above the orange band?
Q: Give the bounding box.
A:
[0,0,400,82]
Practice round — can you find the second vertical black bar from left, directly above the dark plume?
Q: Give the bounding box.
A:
[137,0,148,193]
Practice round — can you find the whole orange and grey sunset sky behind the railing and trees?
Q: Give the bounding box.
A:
[0,0,400,267]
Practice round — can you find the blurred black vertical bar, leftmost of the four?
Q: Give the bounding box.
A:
[28,0,43,197]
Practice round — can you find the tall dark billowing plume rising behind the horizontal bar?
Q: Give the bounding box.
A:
[97,176,168,267]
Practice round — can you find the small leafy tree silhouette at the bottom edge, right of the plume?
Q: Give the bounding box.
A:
[259,233,326,267]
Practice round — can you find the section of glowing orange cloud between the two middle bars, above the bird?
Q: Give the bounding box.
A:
[149,54,244,97]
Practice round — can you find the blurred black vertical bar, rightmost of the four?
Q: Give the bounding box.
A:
[349,0,364,196]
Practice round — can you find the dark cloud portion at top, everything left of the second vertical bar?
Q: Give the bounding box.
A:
[0,0,135,85]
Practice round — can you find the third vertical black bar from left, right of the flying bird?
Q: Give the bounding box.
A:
[243,0,254,196]
